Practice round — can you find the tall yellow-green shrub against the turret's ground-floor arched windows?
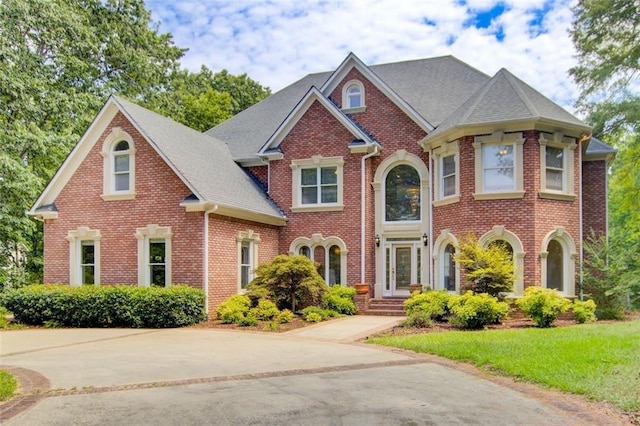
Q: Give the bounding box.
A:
[455,235,515,297]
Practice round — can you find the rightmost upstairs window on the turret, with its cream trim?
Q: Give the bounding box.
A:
[539,133,577,201]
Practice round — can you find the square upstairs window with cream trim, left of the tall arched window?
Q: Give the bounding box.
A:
[291,155,344,212]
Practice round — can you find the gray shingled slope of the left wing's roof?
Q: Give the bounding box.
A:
[113,96,284,218]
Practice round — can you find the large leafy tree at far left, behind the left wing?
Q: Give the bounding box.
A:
[0,0,184,286]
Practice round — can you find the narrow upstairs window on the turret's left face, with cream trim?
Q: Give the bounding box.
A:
[433,141,460,207]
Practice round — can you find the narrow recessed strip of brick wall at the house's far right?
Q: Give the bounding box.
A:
[582,160,607,238]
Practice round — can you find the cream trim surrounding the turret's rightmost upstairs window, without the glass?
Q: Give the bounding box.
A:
[538,133,577,201]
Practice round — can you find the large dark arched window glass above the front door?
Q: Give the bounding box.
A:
[385,164,421,222]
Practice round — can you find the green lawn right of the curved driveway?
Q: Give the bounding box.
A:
[368,320,640,413]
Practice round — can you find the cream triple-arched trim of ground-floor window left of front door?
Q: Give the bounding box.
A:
[289,234,349,287]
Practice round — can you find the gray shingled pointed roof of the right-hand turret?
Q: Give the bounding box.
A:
[427,68,588,139]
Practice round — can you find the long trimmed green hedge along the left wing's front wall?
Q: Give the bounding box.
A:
[0,285,205,328]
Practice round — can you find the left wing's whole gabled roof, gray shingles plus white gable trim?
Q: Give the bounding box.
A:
[31,96,285,225]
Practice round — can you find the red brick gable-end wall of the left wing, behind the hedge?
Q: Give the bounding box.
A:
[44,113,203,287]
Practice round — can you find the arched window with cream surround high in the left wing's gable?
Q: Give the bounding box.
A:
[102,127,136,201]
